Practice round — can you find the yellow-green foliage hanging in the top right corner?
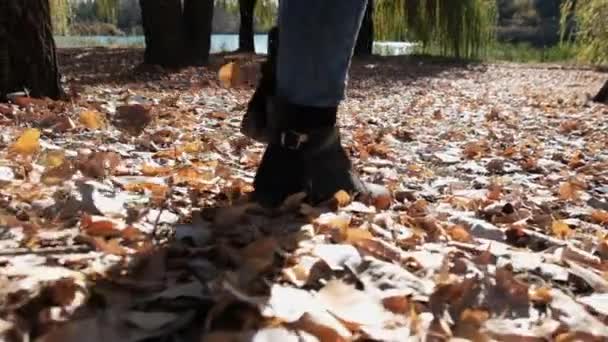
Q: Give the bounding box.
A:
[561,0,608,65]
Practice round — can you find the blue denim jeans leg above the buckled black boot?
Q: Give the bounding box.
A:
[277,0,367,107]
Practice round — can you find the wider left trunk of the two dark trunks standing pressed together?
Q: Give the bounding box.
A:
[139,0,185,68]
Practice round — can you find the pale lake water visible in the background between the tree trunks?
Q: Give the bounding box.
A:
[55,34,416,56]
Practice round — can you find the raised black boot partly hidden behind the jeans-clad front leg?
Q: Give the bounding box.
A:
[241,27,279,142]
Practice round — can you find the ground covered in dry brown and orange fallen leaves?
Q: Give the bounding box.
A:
[0,49,608,342]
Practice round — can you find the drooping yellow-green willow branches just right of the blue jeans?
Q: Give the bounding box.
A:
[374,0,496,57]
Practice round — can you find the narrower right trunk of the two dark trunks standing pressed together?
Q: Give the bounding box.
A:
[184,0,213,66]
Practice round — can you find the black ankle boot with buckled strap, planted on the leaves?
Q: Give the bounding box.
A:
[254,97,387,207]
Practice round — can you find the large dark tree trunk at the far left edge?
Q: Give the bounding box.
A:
[0,0,63,99]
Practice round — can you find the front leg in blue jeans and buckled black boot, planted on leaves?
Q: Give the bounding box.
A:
[254,0,390,206]
